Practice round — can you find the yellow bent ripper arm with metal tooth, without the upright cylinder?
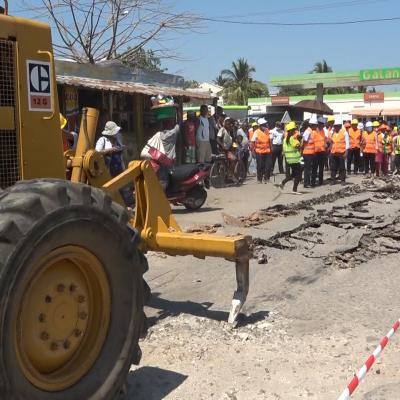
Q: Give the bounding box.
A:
[102,161,250,323]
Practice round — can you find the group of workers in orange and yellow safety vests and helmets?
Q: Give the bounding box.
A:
[248,115,400,193]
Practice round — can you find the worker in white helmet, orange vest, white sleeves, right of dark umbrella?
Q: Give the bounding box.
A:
[330,118,350,185]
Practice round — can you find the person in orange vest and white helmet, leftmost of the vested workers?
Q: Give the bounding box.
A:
[251,118,272,183]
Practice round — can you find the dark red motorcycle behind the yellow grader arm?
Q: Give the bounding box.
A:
[148,147,211,211]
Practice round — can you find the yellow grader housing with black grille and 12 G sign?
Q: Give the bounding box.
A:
[0,15,65,188]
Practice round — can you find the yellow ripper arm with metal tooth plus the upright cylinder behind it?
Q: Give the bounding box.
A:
[70,108,250,323]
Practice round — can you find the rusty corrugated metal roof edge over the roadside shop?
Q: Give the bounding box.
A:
[57,75,212,99]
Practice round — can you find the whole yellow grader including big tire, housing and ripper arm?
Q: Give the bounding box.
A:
[0,5,249,400]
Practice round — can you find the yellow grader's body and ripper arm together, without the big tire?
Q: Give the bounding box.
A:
[0,15,249,328]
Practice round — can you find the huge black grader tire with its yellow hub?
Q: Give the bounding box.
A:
[0,179,147,400]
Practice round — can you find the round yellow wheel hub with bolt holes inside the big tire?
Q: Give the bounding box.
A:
[15,246,110,391]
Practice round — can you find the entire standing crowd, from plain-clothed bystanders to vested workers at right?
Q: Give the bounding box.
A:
[180,105,400,193]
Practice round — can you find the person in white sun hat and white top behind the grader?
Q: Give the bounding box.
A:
[96,121,125,177]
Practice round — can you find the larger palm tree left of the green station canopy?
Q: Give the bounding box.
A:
[220,58,268,105]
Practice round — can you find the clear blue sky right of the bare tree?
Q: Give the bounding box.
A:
[10,0,400,83]
